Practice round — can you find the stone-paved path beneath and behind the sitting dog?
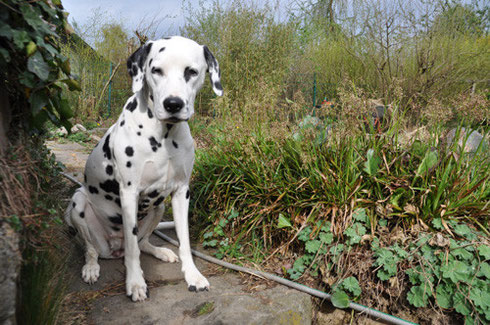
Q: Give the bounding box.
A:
[47,142,313,325]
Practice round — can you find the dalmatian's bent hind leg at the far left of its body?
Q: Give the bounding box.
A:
[66,189,100,284]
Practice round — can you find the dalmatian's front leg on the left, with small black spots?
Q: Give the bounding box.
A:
[120,189,148,301]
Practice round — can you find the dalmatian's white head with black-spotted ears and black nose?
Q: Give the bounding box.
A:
[127,36,223,123]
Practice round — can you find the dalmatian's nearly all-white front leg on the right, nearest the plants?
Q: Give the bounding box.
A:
[172,186,209,291]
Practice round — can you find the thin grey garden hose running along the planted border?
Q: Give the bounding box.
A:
[153,228,415,325]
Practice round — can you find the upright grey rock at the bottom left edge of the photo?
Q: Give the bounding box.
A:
[0,221,21,325]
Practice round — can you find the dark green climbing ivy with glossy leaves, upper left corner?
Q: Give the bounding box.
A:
[0,0,80,131]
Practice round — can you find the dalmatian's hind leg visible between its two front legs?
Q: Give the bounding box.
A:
[139,207,179,263]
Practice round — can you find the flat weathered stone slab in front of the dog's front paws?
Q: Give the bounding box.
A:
[89,274,312,324]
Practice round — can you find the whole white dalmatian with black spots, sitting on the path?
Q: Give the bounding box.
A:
[65,36,223,301]
